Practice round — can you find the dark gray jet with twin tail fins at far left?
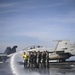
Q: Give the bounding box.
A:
[0,46,17,63]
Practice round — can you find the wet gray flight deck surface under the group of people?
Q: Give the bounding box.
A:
[0,62,75,75]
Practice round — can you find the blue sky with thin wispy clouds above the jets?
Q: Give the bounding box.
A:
[0,0,75,52]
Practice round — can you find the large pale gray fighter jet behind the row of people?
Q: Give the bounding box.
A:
[25,40,75,62]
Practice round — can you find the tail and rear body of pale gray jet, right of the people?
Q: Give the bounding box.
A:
[49,40,75,62]
